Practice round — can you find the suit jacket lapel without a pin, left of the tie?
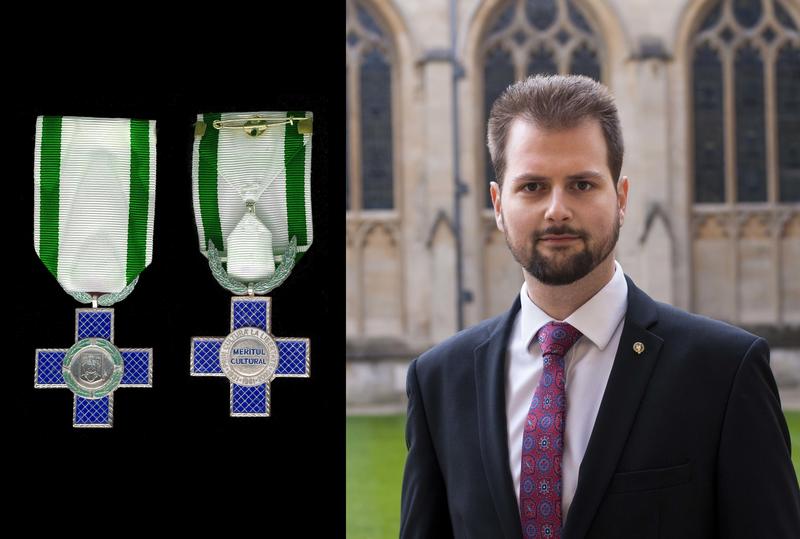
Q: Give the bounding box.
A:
[475,298,522,539]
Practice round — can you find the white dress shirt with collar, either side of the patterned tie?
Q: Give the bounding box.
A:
[505,262,628,521]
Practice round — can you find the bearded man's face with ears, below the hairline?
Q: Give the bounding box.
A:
[491,119,628,285]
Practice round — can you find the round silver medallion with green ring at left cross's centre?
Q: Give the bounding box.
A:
[61,338,124,399]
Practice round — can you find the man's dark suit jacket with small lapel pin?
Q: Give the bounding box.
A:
[400,279,800,539]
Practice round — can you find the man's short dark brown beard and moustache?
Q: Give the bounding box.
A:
[503,219,620,286]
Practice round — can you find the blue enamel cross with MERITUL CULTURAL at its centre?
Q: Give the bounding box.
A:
[191,296,311,417]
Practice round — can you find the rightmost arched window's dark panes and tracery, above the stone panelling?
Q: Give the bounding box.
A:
[692,0,800,204]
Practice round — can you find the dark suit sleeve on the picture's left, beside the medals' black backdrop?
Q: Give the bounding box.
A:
[400,360,453,539]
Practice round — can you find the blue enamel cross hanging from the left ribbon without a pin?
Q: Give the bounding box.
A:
[34,309,153,427]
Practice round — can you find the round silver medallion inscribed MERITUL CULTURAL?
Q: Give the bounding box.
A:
[219,328,278,386]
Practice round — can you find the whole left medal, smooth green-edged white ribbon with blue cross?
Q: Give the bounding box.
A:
[34,116,156,427]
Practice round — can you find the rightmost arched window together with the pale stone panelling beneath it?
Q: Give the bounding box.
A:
[689,0,800,324]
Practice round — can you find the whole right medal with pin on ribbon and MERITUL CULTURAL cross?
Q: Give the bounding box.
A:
[190,112,313,417]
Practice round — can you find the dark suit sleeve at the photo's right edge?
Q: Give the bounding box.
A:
[717,338,800,539]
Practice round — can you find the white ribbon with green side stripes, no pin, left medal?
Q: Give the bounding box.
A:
[33,116,156,295]
